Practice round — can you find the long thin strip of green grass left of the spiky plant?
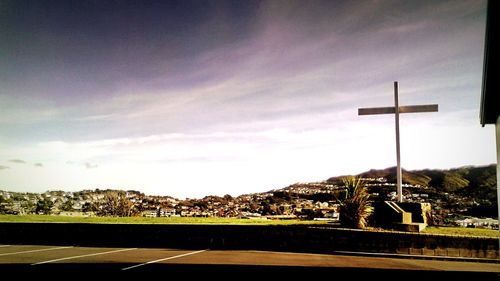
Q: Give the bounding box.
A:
[0,215,327,225]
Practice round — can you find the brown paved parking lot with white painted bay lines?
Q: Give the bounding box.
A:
[0,245,500,280]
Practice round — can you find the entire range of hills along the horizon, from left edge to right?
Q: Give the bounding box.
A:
[0,165,498,222]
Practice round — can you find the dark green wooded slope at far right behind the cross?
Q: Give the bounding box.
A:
[327,164,498,218]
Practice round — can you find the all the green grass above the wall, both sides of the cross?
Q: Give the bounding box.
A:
[0,215,500,237]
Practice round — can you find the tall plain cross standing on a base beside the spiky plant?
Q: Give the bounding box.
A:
[358,81,438,202]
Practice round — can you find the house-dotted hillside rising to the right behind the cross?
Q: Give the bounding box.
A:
[273,164,498,220]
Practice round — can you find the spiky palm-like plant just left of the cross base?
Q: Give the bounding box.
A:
[338,177,373,228]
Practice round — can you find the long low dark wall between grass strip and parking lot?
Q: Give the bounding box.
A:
[0,223,499,258]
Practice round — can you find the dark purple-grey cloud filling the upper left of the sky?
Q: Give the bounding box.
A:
[0,0,259,105]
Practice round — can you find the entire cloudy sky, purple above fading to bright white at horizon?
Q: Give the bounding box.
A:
[0,0,496,198]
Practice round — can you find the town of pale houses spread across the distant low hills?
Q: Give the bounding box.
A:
[0,166,498,228]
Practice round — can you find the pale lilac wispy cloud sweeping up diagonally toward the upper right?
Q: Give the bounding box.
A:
[0,1,483,142]
